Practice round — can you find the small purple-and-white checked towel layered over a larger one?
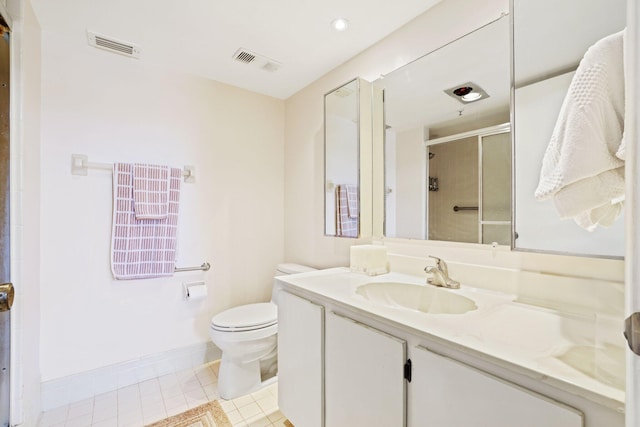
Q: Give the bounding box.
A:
[133,163,170,219]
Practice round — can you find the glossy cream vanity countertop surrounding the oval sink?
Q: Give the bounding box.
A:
[276,268,625,411]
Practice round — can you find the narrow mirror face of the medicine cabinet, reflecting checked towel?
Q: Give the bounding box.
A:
[324,79,360,237]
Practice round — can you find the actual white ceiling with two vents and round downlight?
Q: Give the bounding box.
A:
[32,0,440,99]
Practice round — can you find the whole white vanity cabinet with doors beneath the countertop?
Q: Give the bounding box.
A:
[278,289,624,427]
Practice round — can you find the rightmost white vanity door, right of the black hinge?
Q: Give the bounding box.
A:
[408,347,584,427]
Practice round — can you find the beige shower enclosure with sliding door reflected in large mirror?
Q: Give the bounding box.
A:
[426,125,511,245]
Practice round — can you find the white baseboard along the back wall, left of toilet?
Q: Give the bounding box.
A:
[41,342,222,411]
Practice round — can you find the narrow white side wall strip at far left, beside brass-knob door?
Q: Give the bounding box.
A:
[8,1,41,426]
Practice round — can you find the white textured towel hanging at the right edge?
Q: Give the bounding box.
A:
[535,31,625,231]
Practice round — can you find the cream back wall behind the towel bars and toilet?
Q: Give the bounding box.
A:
[40,32,284,381]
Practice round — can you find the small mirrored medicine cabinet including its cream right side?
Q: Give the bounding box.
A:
[324,78,371,238]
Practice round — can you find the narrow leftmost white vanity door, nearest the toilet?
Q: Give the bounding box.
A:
[278,291,324,427]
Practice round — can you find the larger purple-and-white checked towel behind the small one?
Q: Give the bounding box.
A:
[111,163,182,280]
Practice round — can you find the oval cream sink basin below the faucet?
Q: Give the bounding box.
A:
[356,282,478,314]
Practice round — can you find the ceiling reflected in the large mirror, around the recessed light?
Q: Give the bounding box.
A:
[375,16,510,136]
